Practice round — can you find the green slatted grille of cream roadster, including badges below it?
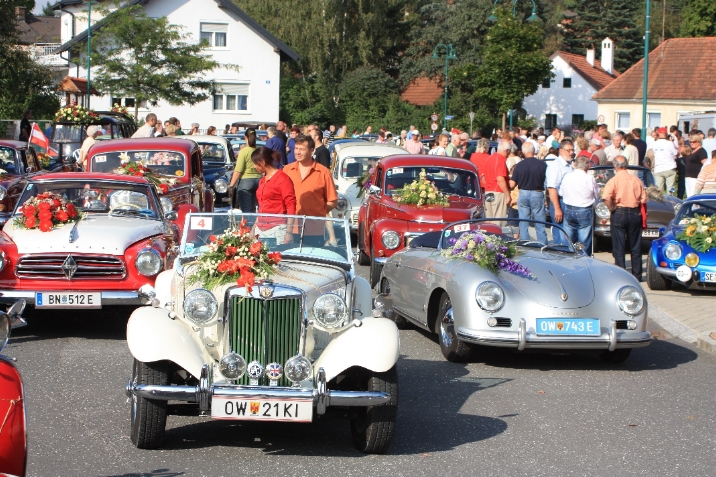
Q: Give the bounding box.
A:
[229,297,301,386]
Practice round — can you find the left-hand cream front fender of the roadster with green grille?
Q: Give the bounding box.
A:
[127,306,211,378]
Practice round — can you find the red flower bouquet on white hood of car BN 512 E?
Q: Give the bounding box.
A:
[15,192,84,232]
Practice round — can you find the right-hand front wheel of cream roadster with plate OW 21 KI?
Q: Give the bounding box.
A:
[351,366,398,454]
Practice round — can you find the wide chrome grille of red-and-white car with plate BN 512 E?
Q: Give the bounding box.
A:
[15,254,126,280]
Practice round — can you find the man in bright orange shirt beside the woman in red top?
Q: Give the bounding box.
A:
[283,134,338,245]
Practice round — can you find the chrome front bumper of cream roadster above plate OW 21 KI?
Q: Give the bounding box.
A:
[125,365,390,414]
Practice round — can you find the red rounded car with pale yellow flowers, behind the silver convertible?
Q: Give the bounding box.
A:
[358,155,483,286]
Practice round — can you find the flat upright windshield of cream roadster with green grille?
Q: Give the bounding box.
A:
[179,210,353,270]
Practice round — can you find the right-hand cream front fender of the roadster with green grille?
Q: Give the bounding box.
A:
[313,318,400,381]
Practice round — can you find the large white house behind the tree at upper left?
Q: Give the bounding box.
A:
[54,0,300,130]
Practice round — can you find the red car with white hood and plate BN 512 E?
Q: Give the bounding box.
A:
[0,172,178,309]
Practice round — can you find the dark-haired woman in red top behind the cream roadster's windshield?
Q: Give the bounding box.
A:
[251,147,296,245]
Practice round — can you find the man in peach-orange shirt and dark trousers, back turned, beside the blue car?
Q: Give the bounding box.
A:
[602,156,646,281]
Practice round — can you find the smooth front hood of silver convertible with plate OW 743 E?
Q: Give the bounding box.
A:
[499,251,594,308]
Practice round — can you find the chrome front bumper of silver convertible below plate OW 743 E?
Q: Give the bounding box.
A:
[457,318,653,351]
